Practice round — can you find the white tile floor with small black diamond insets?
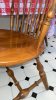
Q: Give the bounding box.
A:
[0,36,56,100]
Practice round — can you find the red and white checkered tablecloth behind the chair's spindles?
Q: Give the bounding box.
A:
[0,0,50,15]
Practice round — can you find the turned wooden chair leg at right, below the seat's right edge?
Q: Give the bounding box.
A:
[36,58,49,90]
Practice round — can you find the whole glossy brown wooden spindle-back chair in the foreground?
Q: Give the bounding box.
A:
[0,0,56,100]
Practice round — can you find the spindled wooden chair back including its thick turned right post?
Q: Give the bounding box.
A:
[10,0,56,48]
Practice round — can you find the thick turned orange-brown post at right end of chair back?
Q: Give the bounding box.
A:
[36,0,56,48]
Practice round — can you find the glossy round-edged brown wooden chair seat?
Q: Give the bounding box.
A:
[0,29,44,67]
